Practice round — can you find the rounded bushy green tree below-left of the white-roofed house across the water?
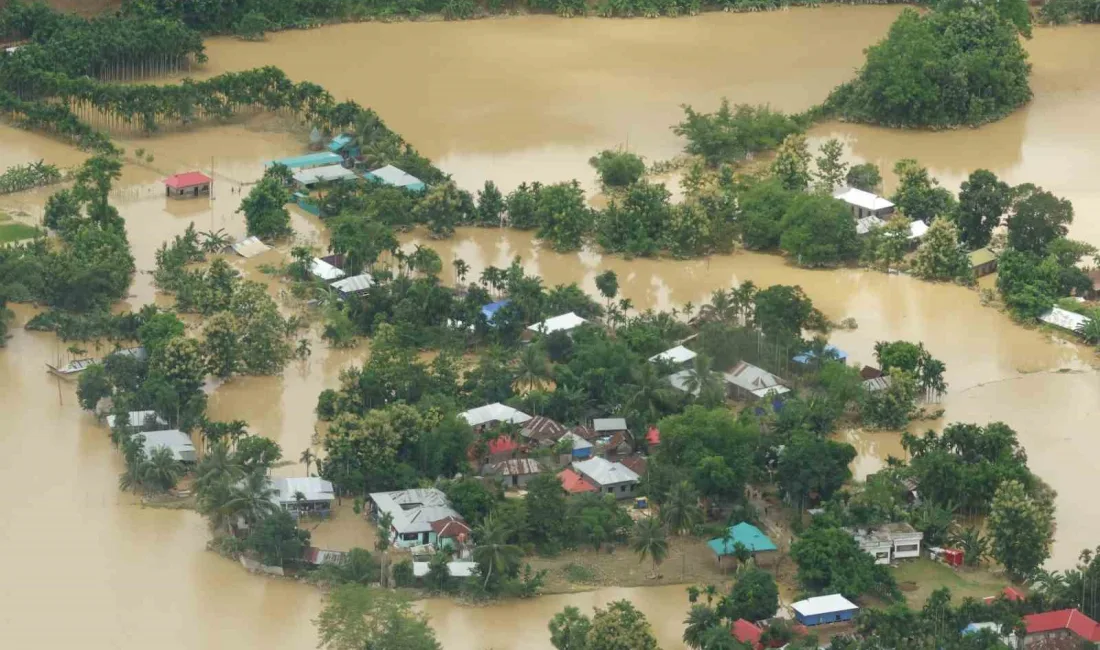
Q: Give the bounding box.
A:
[779,195,859,266]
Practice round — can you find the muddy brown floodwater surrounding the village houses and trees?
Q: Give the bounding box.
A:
[0,8,1100,650]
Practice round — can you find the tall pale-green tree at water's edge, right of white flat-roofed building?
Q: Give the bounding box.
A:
[989,481,1054,577]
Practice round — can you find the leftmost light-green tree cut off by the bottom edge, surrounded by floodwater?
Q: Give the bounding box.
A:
[314,584,441,650]
